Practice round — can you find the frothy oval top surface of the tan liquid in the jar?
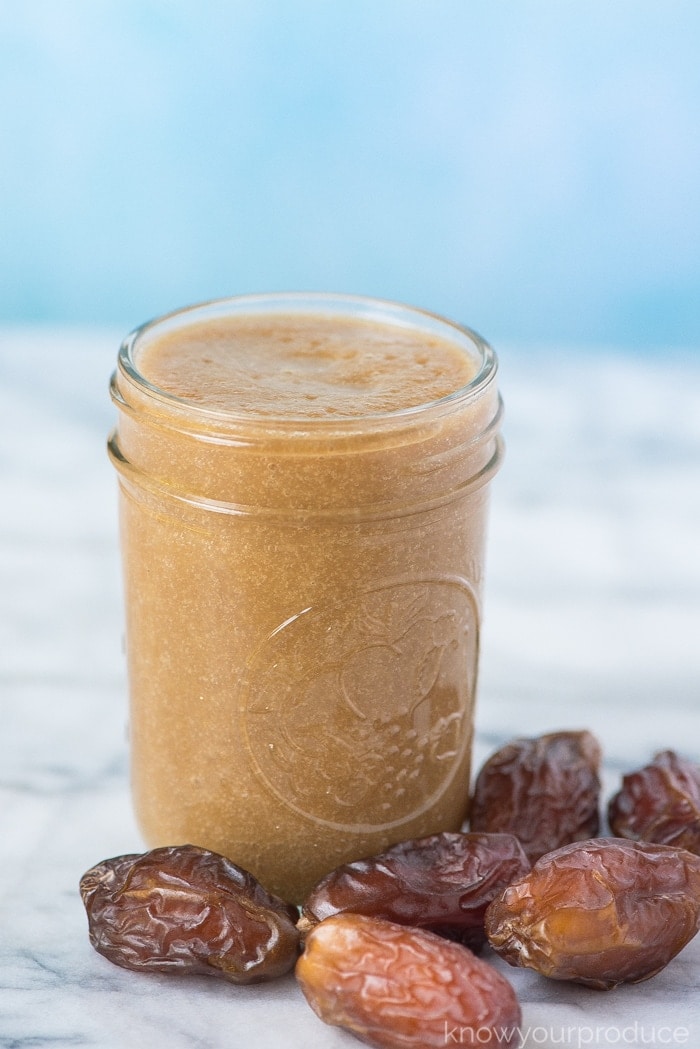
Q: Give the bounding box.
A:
[140,314,476,419]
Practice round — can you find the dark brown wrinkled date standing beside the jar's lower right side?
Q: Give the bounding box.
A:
[469,731,600,863]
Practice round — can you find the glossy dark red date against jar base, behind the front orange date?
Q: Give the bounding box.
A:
[298,832,530,950]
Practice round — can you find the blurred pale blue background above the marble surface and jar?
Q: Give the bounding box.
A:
[0,0,700,350]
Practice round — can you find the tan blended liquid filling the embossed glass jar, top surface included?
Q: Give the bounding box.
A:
[112,297,499,901]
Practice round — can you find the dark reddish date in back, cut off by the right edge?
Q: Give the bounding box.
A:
[608,750,700,856]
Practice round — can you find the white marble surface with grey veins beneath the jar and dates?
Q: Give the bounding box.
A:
[0,329,700,1049]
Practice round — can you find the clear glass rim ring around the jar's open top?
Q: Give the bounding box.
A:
[118,292,497,433]
